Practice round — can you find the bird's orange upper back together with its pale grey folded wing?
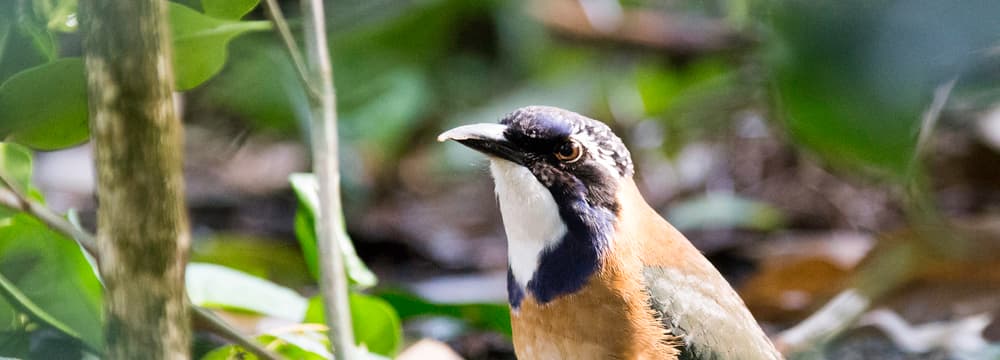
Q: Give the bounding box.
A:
[618,182,781,360]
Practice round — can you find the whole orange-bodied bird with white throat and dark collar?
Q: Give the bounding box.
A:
[437,106,781,360]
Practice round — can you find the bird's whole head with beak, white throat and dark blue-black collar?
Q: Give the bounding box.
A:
[438,106,633,305]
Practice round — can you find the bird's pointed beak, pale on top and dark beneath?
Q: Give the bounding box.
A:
[438,124,524,165]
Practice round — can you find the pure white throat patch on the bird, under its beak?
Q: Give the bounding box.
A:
[490,158,566,289]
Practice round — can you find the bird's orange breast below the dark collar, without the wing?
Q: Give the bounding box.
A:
[511,238,680,360]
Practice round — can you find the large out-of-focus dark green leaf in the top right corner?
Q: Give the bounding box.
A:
[767,0,1000,179]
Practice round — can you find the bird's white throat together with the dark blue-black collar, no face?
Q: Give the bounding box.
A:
[490,159,614,310]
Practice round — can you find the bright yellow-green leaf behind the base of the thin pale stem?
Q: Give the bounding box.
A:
[305,292,403,356]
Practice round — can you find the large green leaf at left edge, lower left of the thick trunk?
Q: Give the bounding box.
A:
[0,215,104,351]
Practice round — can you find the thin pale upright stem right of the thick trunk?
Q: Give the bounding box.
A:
[301,0,357,360]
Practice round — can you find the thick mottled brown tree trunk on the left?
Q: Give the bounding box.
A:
[80,0,190,359]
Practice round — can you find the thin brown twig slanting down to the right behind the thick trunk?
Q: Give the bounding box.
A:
[0,173,282,360]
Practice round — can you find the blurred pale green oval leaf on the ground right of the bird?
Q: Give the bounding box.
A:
[666,193,785,231]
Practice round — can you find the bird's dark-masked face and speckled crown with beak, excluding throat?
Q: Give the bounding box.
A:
[438,106,633,212]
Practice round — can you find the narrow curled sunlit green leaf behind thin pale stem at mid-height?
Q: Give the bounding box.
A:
[289,173,378,289]
